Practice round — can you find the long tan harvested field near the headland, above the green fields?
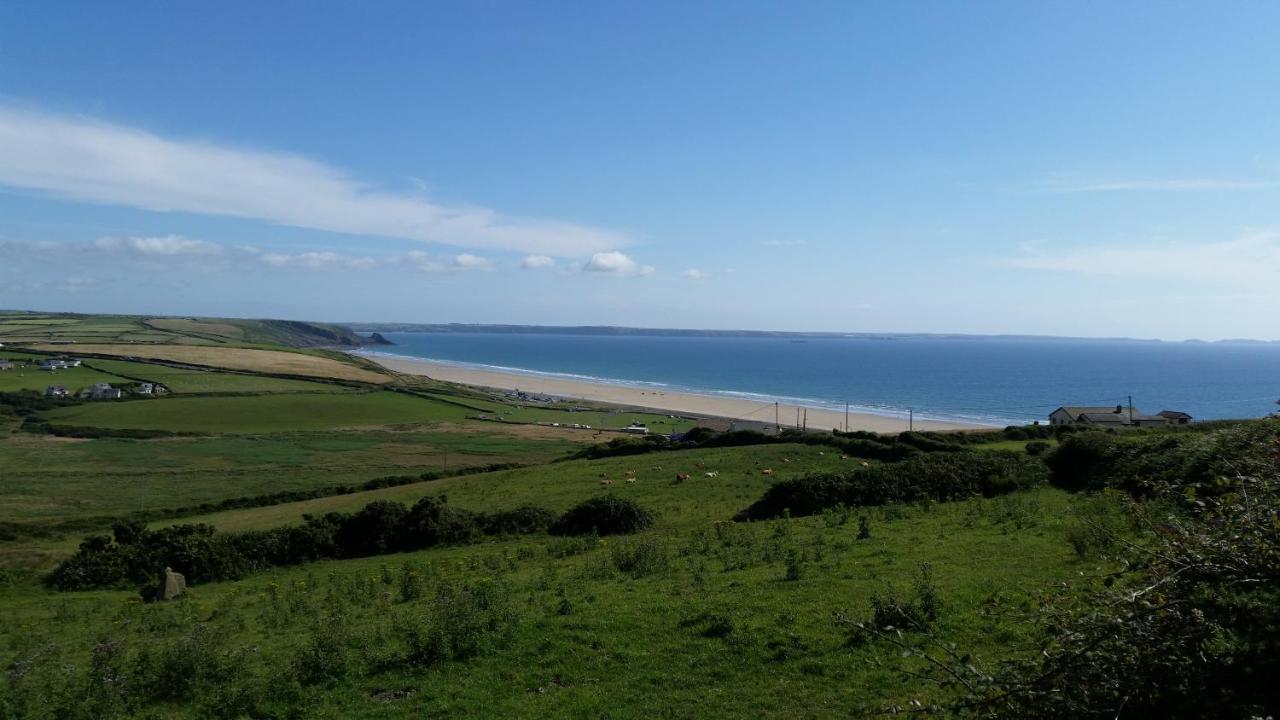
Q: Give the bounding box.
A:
[32,343,390,384]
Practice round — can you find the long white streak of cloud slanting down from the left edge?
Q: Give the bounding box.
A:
[0,106,628,256]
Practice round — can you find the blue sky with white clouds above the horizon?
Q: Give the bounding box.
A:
[0,1,1280,340]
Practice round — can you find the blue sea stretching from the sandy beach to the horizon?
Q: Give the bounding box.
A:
[360,332,1280,425]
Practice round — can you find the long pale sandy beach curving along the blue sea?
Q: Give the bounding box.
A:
[361,354,983,433]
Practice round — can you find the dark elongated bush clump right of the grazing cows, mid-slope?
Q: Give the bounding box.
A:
[735,452,1046,520]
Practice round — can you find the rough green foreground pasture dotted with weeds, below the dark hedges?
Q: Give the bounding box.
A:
[0,476,1094,717]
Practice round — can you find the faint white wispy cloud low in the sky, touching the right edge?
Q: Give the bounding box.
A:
[1007,229,1280,288]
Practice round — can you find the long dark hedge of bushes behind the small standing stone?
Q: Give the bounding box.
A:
[46,496,555,596]
